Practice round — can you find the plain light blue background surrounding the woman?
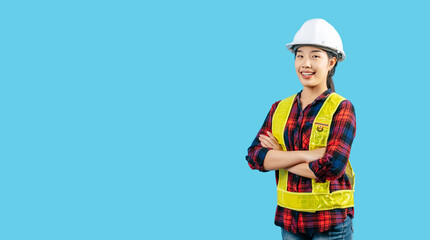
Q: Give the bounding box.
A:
[0,0,430,240]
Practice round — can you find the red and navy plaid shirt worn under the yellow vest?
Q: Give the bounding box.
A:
[246,89,355,235]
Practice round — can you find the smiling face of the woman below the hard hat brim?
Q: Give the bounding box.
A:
[295,46,336,89]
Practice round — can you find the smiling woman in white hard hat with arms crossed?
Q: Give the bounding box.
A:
[246,19,356,239]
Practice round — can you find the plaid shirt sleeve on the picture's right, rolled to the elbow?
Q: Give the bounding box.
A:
[309,100,356,182]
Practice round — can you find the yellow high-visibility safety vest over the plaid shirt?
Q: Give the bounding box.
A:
[272,93,355,212]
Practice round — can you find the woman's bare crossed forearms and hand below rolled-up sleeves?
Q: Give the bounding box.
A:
[259,131,326,179]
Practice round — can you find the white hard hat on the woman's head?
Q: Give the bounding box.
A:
[287,18,346,62]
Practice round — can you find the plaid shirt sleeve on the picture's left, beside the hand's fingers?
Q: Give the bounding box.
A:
[246,101,280,172]
